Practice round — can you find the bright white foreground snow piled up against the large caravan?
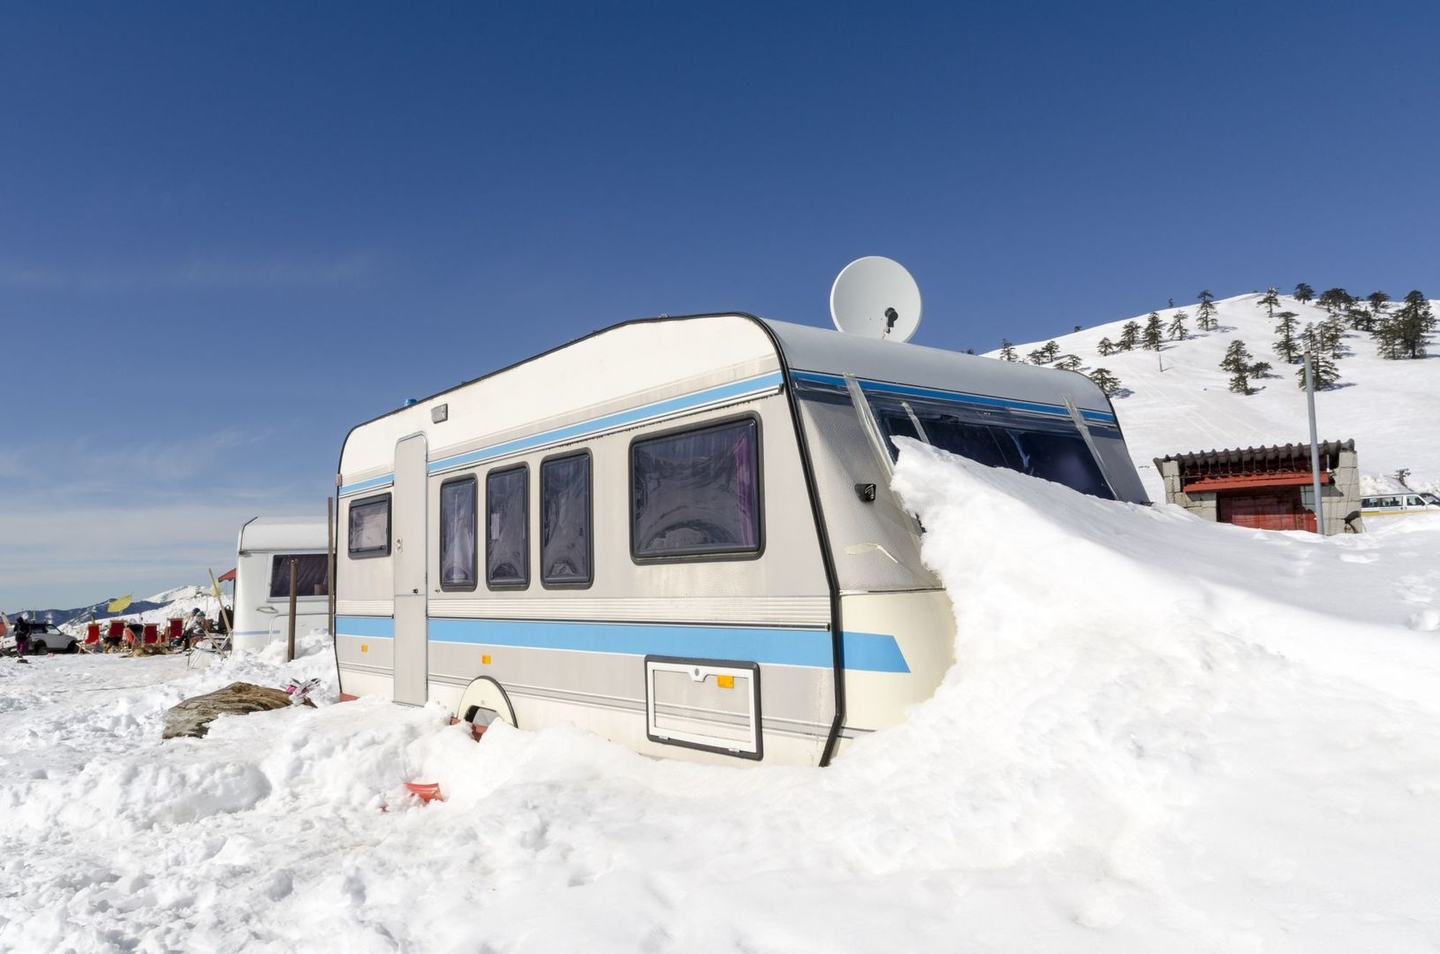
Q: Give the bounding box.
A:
[0,444,1440,953]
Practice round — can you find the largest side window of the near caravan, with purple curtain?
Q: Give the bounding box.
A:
[631,418,762,559]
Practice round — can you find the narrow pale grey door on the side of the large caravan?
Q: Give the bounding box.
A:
[395,434,429,706]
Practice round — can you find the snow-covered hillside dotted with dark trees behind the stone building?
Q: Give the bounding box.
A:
[991,293,1440,500]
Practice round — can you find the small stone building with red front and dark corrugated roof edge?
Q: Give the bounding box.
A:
[1155,441,1364,535]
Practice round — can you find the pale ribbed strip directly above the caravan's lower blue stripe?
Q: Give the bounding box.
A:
[426,597,829,628]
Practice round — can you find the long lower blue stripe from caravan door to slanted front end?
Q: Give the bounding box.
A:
[429,618,910,673]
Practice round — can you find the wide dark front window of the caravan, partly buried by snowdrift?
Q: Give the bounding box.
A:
[865,388,1115,500]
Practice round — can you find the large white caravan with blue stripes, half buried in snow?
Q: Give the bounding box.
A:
[336,314,1145,765]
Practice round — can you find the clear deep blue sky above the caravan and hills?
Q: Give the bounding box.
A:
[0,0,1440,611]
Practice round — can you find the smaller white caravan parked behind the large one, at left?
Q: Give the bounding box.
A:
[233,516,330,651]
